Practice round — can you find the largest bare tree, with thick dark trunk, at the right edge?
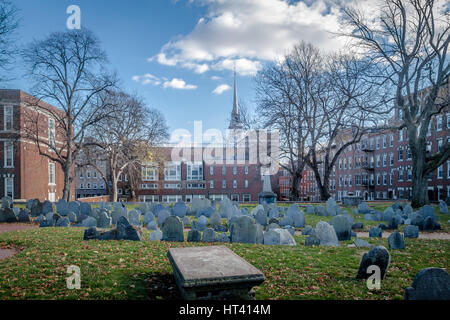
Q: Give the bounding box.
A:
[342,0,450,207]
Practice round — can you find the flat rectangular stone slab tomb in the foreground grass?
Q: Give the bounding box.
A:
[167,246,264,300]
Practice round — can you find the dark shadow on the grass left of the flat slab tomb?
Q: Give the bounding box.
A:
[119,273,183,300]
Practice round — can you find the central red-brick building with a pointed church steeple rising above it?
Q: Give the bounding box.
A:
[76,75,278,203]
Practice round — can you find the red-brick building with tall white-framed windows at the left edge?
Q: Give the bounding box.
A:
[0,89,74,201]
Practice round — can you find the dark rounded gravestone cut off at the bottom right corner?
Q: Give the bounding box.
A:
[405,268,450,300]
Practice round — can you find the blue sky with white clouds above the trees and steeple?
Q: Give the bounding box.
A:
[8,0,446,138]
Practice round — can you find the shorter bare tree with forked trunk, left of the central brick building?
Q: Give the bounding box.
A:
[85,92,168,201]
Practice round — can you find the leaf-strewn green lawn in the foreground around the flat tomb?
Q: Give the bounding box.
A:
[0,225,450,300]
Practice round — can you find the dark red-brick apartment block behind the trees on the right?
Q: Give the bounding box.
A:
[280,82,450,201]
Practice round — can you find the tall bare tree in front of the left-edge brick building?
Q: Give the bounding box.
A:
[22,29,117,201]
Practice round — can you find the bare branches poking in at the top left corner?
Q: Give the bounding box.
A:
[0,0,19,81]
